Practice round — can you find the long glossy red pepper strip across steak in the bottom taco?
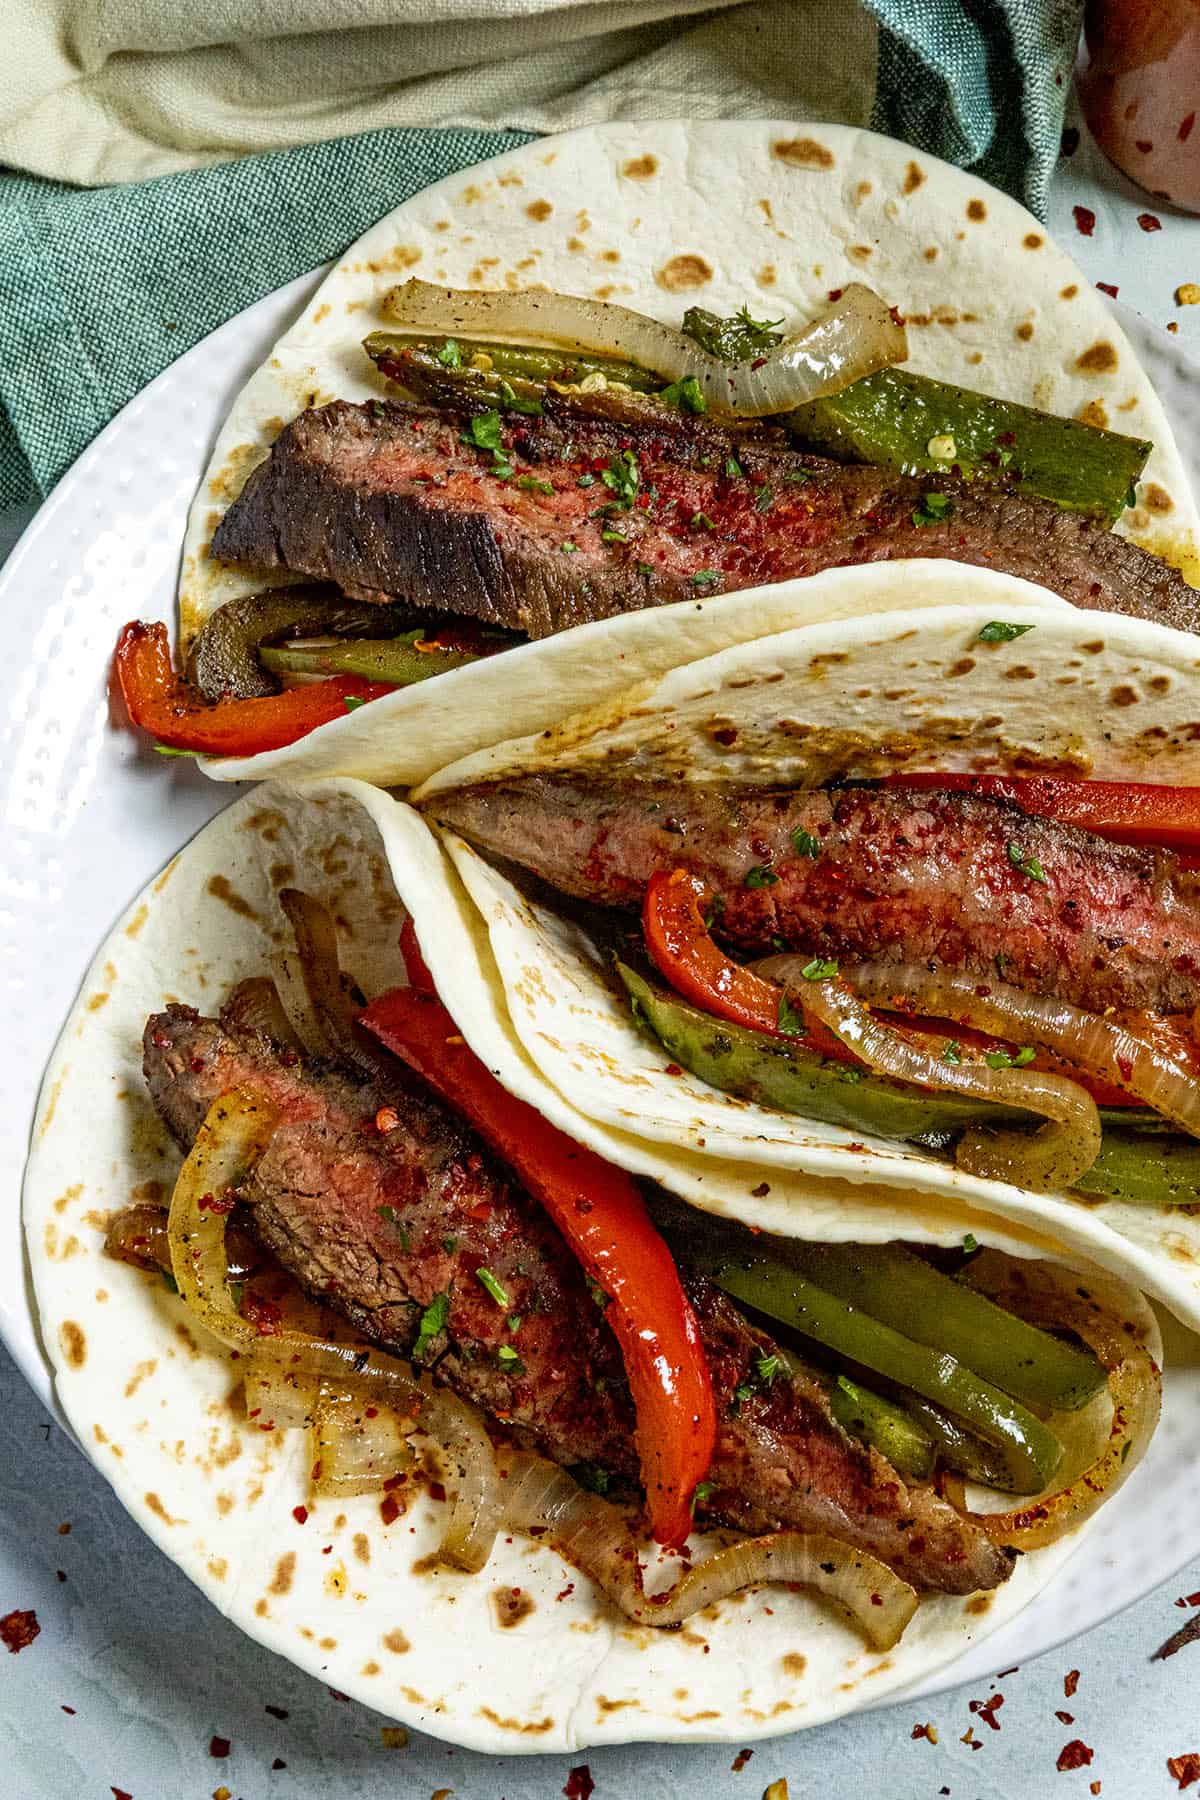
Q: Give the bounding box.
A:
[360,972,716,1548]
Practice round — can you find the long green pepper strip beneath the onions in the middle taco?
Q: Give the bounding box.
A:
[617,959,1200,1206]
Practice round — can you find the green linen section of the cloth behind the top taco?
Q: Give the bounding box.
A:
[0,0,1081,506]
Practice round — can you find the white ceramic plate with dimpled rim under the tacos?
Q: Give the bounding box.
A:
[0,217,1200,1720]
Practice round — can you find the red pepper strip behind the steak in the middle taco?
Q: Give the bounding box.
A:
[885,774,1200,850]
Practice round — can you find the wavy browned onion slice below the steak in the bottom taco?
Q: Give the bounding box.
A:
[504,1454,918,1651]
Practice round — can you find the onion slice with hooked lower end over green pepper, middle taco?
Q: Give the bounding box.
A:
[784,958,1101,1193]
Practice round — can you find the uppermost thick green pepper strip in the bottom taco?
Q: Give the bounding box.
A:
[786,1244,1106,1413]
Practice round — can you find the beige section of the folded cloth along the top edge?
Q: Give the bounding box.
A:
[0,0,876,185]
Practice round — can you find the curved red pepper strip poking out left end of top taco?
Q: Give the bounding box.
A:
[113,621,396,756]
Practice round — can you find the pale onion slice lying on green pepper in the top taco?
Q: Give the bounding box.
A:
[383,281,909,418]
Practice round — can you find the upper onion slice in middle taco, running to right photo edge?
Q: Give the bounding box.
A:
[846,963,1200,1138]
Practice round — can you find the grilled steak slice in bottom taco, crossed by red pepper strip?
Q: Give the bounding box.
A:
[144,1006,1011,1593]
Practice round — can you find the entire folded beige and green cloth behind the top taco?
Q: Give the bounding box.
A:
[0,0,1081,504]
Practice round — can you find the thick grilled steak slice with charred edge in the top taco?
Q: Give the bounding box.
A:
[212,394,1200,637]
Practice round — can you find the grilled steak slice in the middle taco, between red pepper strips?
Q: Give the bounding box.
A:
[428,774,1200,1012]
